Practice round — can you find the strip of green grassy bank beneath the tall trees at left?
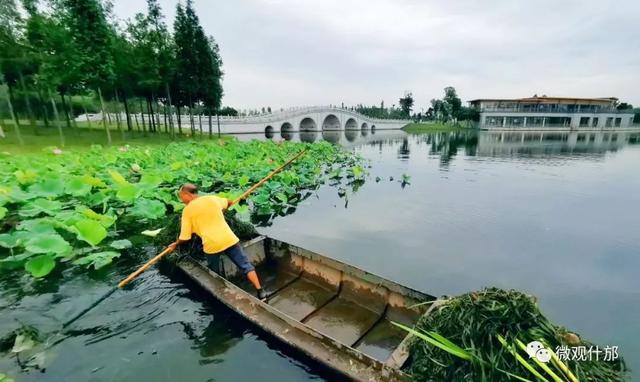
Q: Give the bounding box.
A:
[0,122,228,154]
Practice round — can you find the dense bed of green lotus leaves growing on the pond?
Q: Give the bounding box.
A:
[0,140,366,278]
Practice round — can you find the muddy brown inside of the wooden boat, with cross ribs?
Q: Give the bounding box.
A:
[202,237,435,367]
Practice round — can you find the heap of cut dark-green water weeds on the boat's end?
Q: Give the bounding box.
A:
[396,288,630,382]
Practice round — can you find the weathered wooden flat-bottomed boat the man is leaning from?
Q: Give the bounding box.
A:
[170,236,435,381]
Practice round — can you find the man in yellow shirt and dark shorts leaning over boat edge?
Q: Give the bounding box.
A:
[170,183,267,301]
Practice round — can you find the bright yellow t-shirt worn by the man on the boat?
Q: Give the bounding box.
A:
[180,196,240,254]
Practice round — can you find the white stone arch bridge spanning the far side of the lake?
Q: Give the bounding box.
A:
[209,106,411,134]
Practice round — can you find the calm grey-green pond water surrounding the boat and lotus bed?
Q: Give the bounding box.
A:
[0,130,640,382]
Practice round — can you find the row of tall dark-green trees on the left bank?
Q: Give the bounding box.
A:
[0,0,226,141]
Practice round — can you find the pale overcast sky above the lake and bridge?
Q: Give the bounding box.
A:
[113,0,640,111]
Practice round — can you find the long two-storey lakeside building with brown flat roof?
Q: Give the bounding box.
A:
[469,96,637,130]
